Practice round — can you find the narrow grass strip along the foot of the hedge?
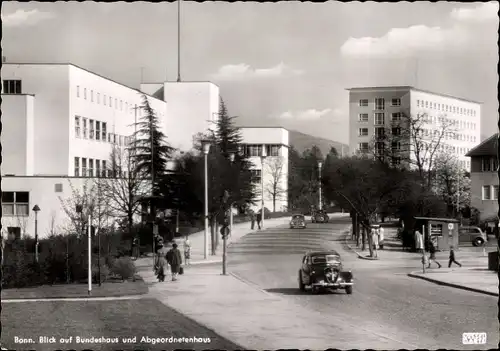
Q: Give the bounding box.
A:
[2,278,148,299]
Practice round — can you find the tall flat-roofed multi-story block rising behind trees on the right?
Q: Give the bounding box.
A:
[348,86,481,170]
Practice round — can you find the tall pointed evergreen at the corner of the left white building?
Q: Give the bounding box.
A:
[130,94,174,194]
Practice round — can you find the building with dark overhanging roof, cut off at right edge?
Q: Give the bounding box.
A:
[467,134,498,222]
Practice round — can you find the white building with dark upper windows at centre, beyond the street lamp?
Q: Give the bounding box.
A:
[240,127,289,211]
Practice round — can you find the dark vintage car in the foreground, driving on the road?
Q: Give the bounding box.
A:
[298,250,353,294]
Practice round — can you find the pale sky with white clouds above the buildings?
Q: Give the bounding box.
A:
[2,1,499,143]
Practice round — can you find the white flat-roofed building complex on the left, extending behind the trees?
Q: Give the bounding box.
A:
[1,63,288,236]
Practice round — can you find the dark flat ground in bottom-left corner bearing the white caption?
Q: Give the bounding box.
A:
[1,298,241,350]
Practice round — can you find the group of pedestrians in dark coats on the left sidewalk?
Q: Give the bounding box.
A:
[155,235,187,282]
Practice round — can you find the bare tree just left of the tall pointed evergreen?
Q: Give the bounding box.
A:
[96,147,150,238]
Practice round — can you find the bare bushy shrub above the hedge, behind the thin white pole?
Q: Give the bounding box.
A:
[59,179,111,235]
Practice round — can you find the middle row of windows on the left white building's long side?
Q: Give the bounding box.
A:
[75,116,132,146]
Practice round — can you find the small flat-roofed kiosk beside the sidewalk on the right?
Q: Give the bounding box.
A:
[415,217,459,251]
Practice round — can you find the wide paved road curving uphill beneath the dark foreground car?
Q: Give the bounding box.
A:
[229,219,498,349]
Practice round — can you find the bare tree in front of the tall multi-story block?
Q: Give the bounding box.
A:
[372,112,458,188]
